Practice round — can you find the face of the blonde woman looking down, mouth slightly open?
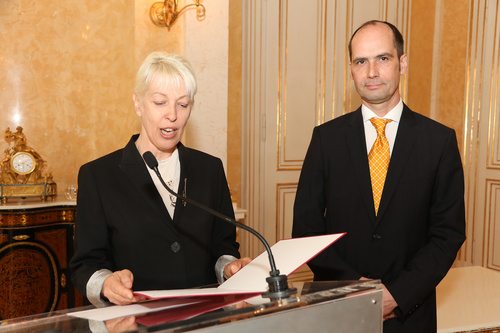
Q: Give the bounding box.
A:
[134,79,192,160]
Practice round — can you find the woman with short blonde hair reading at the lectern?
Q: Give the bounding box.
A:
[70,52,250,306]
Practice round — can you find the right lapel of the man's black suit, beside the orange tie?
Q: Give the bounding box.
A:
[376,105,418,223]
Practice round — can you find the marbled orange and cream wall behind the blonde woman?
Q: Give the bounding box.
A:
[0,0,228,192]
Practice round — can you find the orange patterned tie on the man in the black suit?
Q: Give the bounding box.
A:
[368,118,391,214]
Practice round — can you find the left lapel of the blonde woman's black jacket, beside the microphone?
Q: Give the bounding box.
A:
[120,135,176,228]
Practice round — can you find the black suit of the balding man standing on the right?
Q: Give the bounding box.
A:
[293,105,465,332]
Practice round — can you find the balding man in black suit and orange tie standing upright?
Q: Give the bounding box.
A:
[292,21,465,332]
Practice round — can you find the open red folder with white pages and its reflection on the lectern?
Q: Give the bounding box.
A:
[68,233,345,321]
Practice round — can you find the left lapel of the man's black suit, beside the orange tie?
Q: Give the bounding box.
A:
[346,108,375,220]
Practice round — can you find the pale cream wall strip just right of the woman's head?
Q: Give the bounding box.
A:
[184,0,229,170]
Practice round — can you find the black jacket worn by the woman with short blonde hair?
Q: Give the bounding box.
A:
[70,136,239,295]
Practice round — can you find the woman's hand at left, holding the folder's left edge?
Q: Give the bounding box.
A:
[102,269,146,305]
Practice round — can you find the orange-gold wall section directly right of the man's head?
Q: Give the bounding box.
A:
[407,0,470,146]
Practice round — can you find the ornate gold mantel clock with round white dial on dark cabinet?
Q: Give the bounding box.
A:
[0,126,57,203]
